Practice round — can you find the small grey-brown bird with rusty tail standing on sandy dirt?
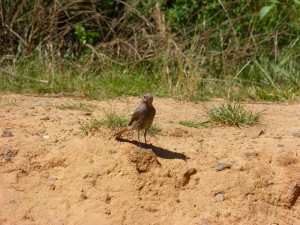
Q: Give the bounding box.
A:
[114,93,156,147]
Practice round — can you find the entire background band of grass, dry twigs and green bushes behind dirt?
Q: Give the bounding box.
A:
[0,0,300,101]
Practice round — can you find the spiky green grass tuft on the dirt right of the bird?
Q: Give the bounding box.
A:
[205,102,262,127]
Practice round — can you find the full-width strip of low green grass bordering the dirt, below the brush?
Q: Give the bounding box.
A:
[0,42,300,101]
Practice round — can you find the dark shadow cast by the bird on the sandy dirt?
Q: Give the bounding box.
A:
[116,137,187,161]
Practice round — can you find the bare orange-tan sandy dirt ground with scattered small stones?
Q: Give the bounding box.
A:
[0,94,300,225]
